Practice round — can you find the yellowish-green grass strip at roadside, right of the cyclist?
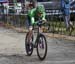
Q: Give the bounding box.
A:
[45,21,75,36]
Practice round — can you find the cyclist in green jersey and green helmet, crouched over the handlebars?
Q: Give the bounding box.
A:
[28,5,46,43]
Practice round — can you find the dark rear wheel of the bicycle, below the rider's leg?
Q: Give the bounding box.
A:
[25,32,33,56]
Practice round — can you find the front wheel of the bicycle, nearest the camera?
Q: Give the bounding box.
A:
[37,34,47,60]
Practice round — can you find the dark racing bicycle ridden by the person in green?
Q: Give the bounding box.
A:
[25,21,47,60]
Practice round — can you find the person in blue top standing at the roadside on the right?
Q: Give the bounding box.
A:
[61,0,73,30]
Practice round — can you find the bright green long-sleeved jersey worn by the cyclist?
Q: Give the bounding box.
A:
[28,8,45,24]
